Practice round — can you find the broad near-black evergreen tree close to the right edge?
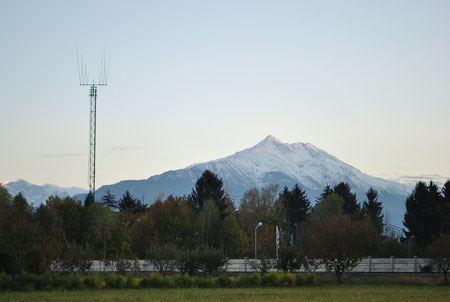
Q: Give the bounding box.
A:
[403,182,442,245]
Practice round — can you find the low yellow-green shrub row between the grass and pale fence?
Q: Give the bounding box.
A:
[0,272,315,291]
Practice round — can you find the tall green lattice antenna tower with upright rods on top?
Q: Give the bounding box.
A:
[77,46,109,201]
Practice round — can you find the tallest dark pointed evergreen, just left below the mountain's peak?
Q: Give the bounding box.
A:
[188,170,230,219]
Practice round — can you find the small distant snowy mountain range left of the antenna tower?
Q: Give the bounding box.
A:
[3,180,87,207]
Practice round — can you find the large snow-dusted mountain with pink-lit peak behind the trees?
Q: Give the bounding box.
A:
[96,136,410,224]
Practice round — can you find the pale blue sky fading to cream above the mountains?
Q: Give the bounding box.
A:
[0,0,450,188]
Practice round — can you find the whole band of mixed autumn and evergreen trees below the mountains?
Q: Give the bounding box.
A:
[0,170,450,278]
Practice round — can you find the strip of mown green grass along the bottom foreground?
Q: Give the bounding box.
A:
[0,285,450,302]
